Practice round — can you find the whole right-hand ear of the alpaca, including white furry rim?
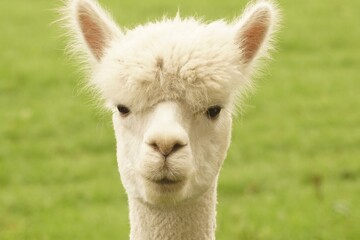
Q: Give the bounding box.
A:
[235,1,279,65]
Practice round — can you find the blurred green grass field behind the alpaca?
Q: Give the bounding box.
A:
[0,0,360,240]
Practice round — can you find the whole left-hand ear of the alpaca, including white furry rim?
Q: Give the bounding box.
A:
[64,0,122,61]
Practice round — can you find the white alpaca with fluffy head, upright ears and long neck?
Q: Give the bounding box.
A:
[64,0,278,240]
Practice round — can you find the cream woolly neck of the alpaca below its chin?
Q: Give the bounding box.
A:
[129,187,216,240]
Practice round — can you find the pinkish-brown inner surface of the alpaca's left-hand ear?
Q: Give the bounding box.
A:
[78,9,108,60]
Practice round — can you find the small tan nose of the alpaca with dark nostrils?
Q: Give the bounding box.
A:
[148,138,187,157]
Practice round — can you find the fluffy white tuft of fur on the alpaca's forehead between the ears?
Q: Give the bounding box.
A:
[93,17,248,110]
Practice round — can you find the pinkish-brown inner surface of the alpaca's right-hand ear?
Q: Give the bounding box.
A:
[239,11,270,63]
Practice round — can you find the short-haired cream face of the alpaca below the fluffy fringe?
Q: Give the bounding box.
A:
[113,101,231,204]
